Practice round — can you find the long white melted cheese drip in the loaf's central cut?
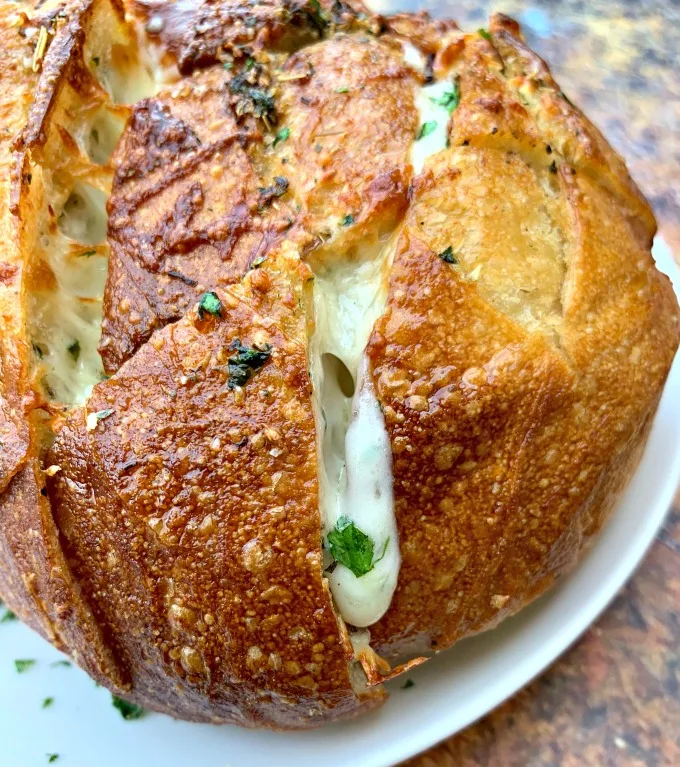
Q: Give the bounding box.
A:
[311,255,400,627]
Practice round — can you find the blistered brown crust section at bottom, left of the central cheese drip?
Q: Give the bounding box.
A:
[49,280,380,728]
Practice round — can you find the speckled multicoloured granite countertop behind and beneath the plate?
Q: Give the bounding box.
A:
[371,0,680,767]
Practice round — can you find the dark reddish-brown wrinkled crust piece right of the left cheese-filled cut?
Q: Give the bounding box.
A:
[100,67,295,372]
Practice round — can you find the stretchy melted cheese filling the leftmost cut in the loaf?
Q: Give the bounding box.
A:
[28,34,159,405]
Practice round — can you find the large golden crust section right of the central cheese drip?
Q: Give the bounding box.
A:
[369,25,679,653]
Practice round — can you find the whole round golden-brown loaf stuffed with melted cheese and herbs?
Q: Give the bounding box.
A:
[0,0,678,728]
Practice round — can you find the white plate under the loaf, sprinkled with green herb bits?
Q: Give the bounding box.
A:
[0,241,680,767]
